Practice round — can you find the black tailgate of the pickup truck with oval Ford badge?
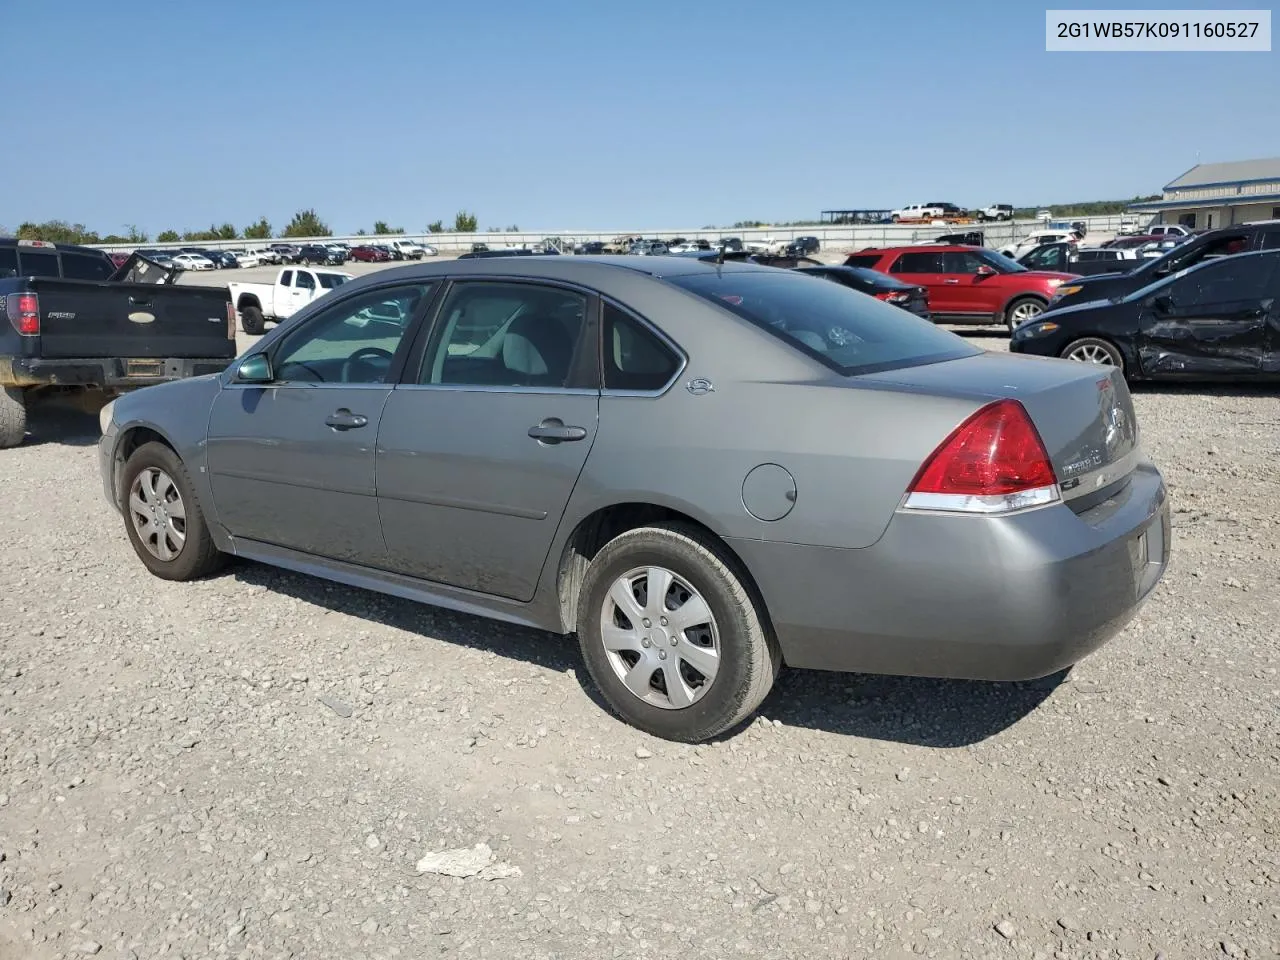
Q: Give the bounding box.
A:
[31,278,236,360]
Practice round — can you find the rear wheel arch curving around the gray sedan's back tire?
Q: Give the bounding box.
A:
[556,500,773,634]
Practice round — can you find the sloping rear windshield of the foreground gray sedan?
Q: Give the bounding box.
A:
[668,270,982,376]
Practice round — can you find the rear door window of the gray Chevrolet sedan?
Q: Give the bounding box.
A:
[419,282,586,388]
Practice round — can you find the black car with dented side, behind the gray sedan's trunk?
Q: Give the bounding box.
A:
[1009,250,1280,380]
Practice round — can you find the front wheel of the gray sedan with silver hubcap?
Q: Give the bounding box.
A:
[120,442,227,580]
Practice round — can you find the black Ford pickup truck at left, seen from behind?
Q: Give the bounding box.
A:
[0,239,236,449]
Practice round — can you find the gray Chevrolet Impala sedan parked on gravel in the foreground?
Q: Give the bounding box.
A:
[99,257,1170,741]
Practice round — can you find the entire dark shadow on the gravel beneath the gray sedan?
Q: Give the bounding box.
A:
[230,561,1066,748]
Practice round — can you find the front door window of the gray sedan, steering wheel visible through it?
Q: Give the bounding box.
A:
[271,283,433,384]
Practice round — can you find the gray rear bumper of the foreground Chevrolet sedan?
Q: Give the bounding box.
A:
[730,463,1171,680]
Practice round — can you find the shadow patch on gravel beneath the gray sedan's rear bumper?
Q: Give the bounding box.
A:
[760,671,1068,748]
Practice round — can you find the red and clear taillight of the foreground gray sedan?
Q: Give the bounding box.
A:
[904,399,1061,513]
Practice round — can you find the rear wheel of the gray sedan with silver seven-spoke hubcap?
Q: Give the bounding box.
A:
[577,524,782,744]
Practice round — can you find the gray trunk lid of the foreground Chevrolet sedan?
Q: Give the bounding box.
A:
[859,352,1139,508]
